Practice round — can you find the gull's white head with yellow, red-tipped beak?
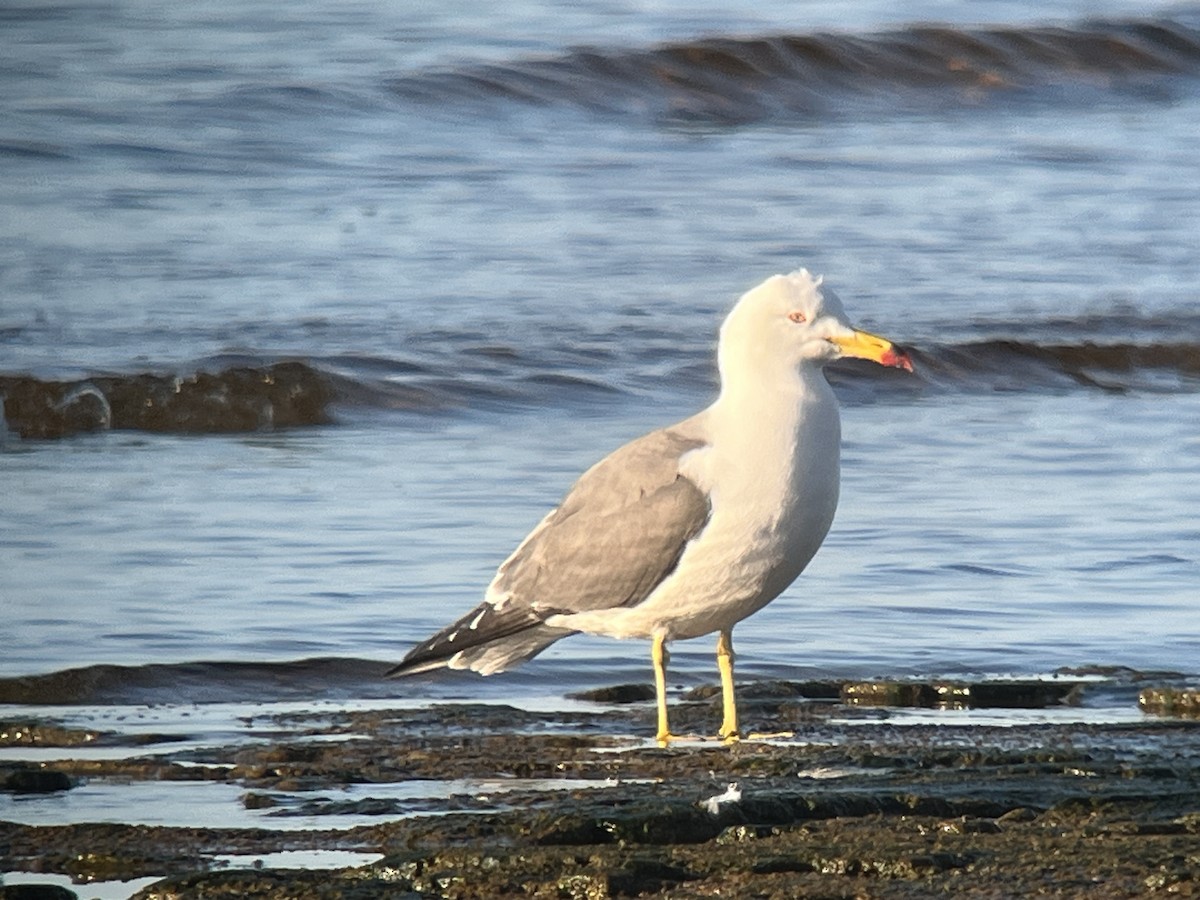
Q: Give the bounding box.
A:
[718,269,912,391]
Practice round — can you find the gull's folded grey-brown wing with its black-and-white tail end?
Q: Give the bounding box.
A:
[389,422,709,674]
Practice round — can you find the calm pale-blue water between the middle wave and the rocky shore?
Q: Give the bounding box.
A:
[4,392,1200,702]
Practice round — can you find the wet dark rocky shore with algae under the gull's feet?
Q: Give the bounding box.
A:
[0,679,1200,900]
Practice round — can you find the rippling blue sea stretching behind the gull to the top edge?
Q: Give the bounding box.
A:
[0,0,1200,701]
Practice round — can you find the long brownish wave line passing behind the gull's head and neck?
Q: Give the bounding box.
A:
[0,337,1200,439]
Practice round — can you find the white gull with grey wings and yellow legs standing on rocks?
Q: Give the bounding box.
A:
[388,269,912,745]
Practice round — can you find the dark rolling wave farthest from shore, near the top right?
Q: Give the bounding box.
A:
[386,19,1200,124]
